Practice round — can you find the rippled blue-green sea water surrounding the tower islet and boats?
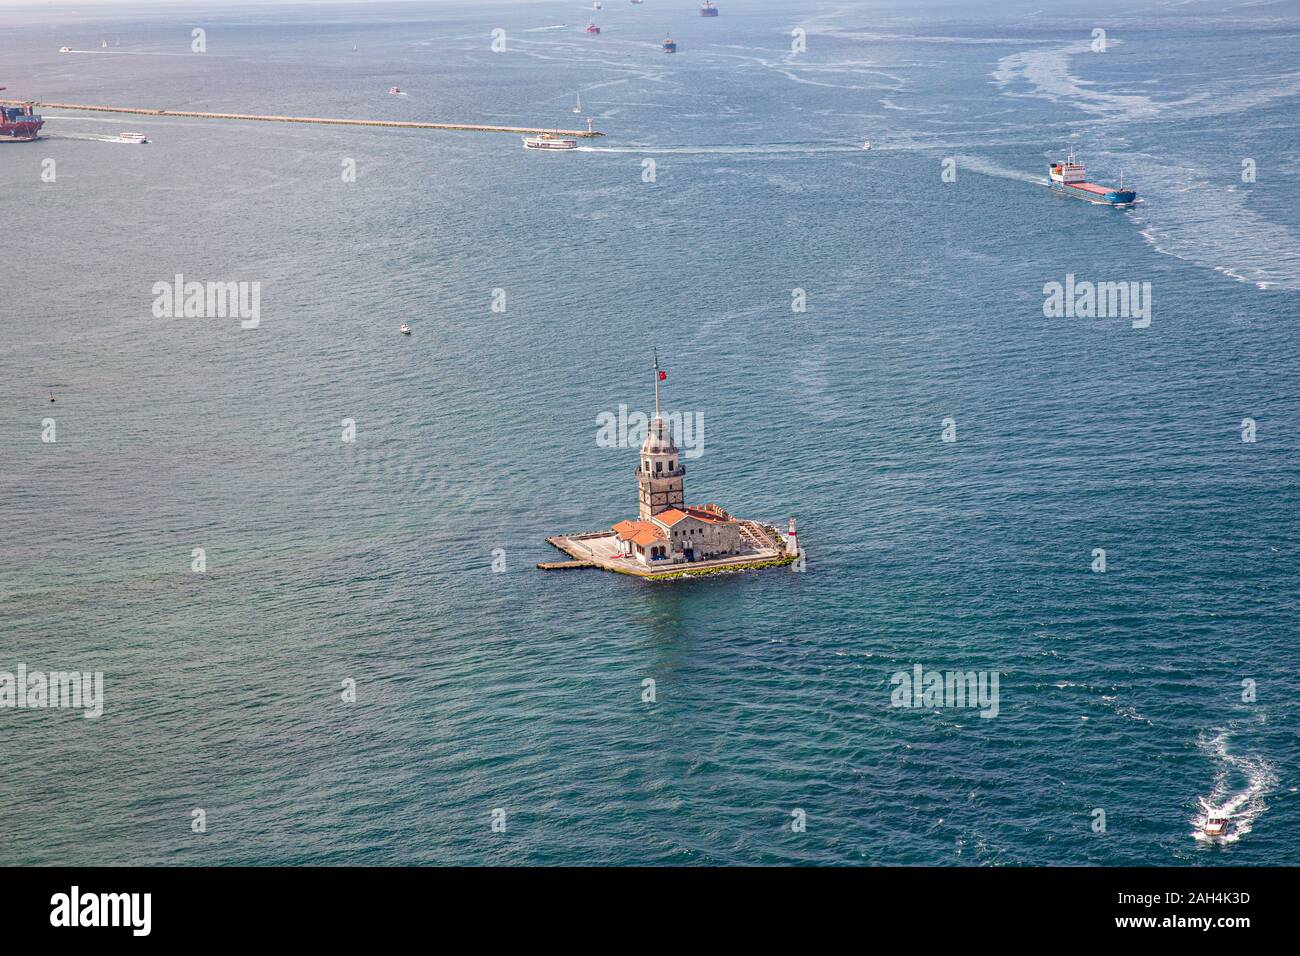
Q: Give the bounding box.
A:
[0,0,1300,865]
